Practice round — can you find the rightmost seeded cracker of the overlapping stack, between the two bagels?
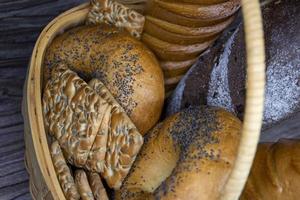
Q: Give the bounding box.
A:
[89,79,143,189]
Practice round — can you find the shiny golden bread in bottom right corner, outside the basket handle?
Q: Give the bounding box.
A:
[240,140,300,200]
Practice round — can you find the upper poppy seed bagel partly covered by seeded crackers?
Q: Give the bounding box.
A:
[44,24,164,134]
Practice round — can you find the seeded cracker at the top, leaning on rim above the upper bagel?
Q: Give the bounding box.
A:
[88,0,145,38]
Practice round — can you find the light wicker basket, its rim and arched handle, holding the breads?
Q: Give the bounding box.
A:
[23,0,265,200]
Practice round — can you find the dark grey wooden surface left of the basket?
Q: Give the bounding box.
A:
[0,0,86,200]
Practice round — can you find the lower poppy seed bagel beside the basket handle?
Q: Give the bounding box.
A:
[116,107,241,200]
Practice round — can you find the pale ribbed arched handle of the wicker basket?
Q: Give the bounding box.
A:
[220,0,265,200]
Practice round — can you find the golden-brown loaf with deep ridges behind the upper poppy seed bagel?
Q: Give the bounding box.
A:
[142,0,240,88]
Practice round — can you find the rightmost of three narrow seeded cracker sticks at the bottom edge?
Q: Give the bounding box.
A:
[88,172,109,200]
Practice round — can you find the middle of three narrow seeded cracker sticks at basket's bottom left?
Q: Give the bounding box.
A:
[75,169,94,200]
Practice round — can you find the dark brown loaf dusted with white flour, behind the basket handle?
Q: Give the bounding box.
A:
[167,0,300,130]
